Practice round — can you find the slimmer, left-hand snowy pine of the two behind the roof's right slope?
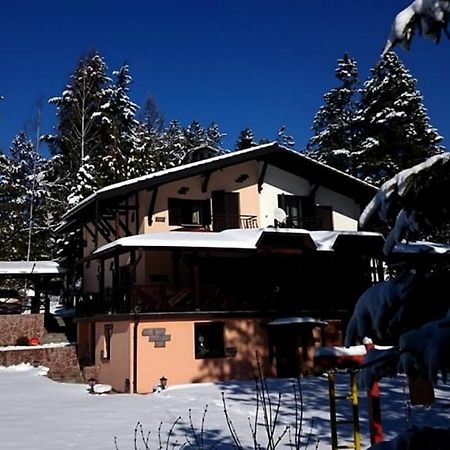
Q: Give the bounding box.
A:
[306,54,359,175]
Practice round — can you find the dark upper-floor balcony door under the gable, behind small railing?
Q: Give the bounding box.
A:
[212,191,241,231]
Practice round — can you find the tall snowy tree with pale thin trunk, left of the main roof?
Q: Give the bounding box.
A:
[44,52,110,278]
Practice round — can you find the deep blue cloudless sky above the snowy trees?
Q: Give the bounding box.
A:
[0,0,450,155]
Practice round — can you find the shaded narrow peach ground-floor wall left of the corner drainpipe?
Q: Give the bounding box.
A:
[95,321,133,392]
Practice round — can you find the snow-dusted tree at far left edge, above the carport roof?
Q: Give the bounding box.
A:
[0,131,49,260]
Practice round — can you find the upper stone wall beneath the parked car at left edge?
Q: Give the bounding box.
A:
[0,314,46,346]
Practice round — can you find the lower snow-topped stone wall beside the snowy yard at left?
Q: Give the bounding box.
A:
[0,345,81,381]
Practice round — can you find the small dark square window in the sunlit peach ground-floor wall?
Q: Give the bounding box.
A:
[194,322,225,359]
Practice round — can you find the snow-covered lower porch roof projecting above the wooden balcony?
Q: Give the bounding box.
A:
[93,227,384,256]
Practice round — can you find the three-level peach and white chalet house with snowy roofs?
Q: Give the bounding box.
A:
[60,143,383,393]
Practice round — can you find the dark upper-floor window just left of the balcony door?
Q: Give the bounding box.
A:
[168,198,211,225]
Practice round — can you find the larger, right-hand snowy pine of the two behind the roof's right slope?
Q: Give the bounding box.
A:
[355,52,443,186]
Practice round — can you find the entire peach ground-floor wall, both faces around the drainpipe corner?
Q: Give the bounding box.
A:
[95,319,273,393]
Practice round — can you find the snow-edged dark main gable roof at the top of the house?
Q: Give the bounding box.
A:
[60,142,376,229]
